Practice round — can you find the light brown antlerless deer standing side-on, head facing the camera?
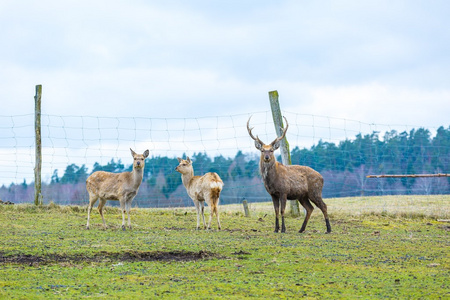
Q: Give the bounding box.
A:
[86,149,149,230]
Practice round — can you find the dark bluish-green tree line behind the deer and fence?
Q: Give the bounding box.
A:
[0,127,450,207]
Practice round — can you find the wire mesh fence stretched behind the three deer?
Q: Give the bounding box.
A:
[0,111,450,207]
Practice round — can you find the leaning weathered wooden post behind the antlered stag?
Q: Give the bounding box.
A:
[269,91,300,216]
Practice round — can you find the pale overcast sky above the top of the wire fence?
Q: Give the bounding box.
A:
[0,0,450,128]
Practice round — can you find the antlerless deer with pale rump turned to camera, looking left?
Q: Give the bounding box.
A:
[175,157,223,230]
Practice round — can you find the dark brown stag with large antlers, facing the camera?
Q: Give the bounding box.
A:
[247,117,331,233]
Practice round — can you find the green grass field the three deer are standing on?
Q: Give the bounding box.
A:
[0,195,450,299]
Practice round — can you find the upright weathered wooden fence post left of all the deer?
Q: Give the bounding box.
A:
[34,85,42,205]
